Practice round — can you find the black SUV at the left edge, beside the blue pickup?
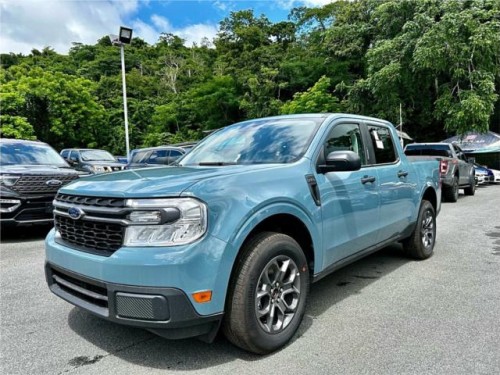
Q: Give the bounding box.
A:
[0,138,79,227]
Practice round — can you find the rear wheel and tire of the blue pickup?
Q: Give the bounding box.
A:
[403,200,436,260]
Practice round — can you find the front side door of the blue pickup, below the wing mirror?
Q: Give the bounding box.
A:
[316,122,379,268]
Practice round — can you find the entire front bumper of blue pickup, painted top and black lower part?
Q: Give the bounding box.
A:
[45,229,232,338]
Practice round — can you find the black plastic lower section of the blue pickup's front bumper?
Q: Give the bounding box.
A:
[45,262,222,341]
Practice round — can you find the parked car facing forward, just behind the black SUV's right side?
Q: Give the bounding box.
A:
[61,148,125,174]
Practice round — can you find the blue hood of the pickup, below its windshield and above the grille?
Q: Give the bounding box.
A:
[59,164,279,198]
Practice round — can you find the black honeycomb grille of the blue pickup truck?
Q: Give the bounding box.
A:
[54,194,126,256]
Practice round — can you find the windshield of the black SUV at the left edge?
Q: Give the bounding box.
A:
[0,142,68,167]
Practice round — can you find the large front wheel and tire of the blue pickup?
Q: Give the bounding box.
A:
[222,232,309,354]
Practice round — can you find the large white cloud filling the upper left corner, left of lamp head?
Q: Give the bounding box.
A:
[0,0,139,54]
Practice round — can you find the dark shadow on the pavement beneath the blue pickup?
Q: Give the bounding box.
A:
[68,244,410,370]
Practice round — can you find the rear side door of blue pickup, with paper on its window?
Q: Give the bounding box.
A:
[367,123,418,243]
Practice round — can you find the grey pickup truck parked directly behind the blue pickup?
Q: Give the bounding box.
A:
[405,143,476,202]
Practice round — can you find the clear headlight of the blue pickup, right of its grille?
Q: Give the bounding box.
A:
[123,198,207,246]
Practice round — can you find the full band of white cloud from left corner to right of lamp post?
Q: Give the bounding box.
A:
[0,0,217,54]
